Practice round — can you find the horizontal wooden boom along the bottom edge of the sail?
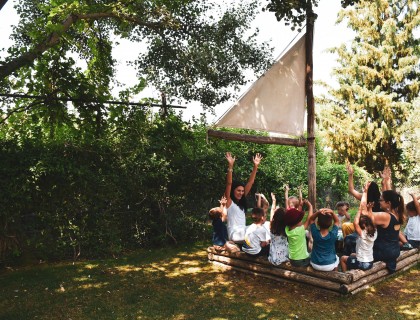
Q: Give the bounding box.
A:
[207,129,306,147]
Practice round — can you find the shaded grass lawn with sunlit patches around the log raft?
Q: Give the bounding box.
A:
[0,243,420,320]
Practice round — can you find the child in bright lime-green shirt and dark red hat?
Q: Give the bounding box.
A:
[284,200,313,267]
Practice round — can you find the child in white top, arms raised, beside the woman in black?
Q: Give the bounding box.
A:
[340,184,378,272]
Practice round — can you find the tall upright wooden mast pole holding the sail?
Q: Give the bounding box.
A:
[305,0,316,208]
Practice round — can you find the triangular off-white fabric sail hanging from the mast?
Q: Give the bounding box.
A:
[215,35,306,136]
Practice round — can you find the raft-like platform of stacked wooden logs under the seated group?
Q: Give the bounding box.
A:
[207,247,420,294]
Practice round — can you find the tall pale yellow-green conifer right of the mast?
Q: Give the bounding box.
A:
[320,0,420,172]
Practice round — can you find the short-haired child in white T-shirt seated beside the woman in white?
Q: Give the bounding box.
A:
[242,208,270,256]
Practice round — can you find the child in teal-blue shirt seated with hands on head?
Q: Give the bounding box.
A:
[309,208,340,271]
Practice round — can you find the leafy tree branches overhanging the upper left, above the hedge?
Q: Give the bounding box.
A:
[0,0,271,110]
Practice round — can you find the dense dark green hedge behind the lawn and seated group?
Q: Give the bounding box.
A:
[0,109,368,260]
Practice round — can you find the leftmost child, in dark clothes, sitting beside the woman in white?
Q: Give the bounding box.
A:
[209,197,239,252]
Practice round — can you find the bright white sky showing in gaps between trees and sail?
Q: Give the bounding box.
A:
[0,0,354,121]
